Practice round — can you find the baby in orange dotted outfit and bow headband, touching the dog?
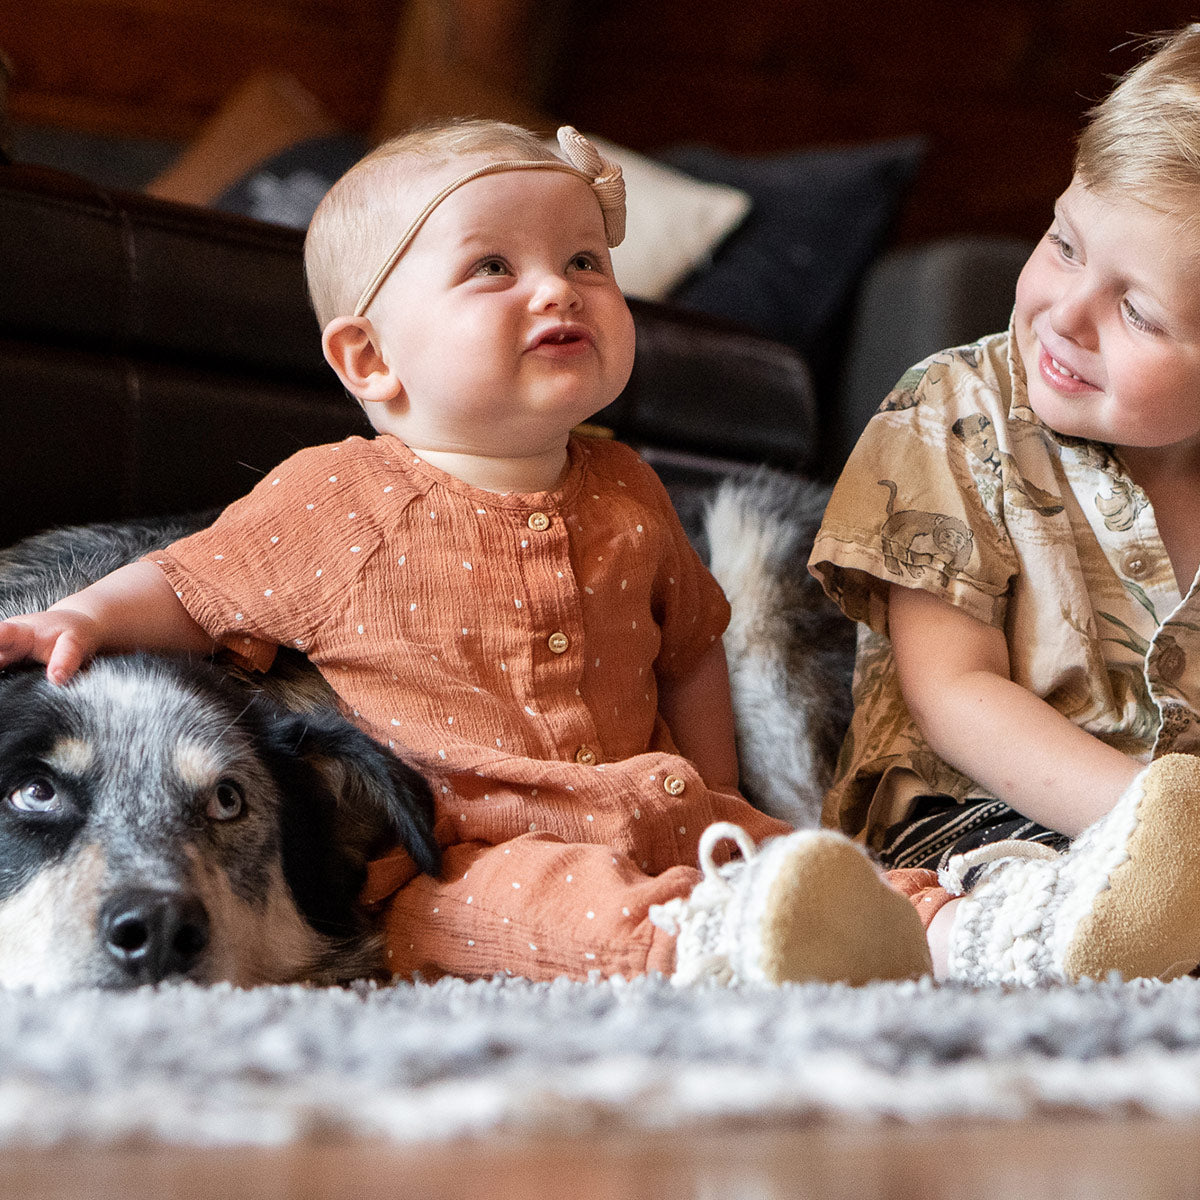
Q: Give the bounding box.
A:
[0,122,929,983]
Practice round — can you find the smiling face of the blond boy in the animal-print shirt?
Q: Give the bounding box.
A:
[1015,176,1200,451]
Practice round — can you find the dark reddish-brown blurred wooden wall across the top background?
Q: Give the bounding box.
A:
[0,0,1193,241]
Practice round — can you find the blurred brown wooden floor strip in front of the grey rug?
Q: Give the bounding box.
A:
[9,1118,1200,1200]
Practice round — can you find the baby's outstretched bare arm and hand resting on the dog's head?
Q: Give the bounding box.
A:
[0,562,214,684]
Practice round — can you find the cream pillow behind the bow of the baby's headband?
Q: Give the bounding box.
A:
[550,133,751,300]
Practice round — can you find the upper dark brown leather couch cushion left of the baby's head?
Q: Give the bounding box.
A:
[0,167,326,392]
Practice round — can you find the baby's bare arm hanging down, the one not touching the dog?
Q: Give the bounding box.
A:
[659,640,738,790]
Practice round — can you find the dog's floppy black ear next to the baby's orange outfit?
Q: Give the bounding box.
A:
[267,712,442,875]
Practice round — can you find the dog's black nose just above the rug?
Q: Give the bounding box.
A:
[100,888,209,984]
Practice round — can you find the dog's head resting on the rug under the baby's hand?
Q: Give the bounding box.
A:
[0,655,438,990]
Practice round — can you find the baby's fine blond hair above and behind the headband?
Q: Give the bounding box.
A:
[304,120,558,329]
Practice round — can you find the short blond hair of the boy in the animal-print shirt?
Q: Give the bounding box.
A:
[1075,24,1200,216]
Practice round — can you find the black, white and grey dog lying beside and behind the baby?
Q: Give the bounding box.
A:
[0,473,852,989]
